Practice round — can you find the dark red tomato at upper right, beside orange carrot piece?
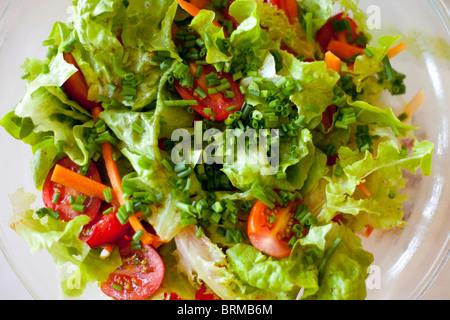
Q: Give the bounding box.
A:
[316,12,358,52]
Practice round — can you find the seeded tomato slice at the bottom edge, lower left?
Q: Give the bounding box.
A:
[101,239,165,300]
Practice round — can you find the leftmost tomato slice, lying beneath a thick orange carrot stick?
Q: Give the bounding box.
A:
[42,157,102,221]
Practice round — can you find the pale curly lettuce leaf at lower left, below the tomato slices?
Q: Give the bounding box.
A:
[10,189,122,297]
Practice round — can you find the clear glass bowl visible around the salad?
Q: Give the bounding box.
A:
[0,0,450,299]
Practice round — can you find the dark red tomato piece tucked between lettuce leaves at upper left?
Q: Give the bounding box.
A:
[62,52,99,111]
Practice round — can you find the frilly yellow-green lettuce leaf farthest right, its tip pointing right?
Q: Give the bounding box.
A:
[319,141,434,230]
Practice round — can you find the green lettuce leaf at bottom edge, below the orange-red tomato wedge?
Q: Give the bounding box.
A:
[226,223,373,300]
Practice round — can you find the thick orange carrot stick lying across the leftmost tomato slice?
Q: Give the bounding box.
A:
[51,164,118,205]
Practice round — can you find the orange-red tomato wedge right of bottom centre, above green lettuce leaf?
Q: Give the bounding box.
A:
[247,201,306,258]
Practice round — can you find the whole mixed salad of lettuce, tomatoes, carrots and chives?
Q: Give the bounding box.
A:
[0,0,434,300]
